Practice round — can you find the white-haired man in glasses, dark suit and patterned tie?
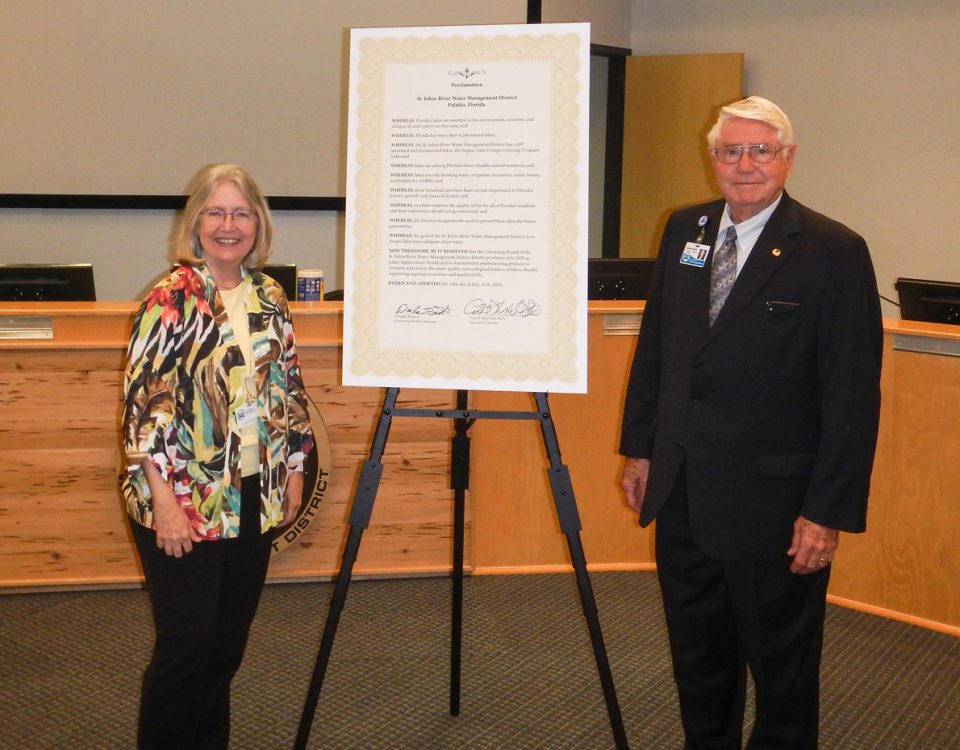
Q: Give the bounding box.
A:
[620,97,882,750]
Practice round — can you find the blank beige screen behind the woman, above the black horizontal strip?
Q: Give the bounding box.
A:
[0,0,526,195]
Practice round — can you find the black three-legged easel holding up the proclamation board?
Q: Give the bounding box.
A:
[294,388,628,750]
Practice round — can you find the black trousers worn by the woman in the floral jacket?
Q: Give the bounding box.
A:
[130,476,273,750]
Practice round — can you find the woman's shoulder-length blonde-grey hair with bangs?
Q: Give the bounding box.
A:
[174,164,273,271]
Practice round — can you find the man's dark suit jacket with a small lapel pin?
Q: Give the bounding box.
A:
[620,193,882,559]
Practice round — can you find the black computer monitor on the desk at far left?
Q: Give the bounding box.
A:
[0,263,97,302]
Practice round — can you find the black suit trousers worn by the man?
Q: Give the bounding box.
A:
[656,472,830,750]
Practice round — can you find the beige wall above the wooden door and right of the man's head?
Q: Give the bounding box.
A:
[632,0,960,317]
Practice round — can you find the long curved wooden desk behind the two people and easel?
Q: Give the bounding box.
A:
[0,302,960,635]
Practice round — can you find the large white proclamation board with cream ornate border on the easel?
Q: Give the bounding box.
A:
[343,24,590,393]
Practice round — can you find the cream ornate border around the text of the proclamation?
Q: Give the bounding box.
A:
[349,29,587,383]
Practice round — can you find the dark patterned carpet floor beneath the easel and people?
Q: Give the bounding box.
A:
[0,573,960,750]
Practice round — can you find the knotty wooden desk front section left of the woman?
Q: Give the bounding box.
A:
[0,348,140,586]
